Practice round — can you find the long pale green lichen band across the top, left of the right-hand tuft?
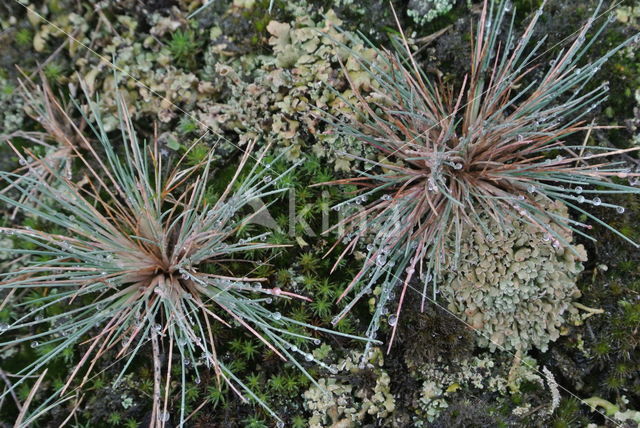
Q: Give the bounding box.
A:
[21,5,375,171]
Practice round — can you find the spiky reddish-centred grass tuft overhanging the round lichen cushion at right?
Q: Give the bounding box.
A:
[324,1,640,354]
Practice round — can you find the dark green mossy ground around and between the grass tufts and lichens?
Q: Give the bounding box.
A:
[0,0,640,427]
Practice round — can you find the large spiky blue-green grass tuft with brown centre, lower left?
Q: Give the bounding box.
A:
[0,81,368,426]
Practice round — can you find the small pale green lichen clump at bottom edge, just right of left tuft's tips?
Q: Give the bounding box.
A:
[303,348,395,428]
